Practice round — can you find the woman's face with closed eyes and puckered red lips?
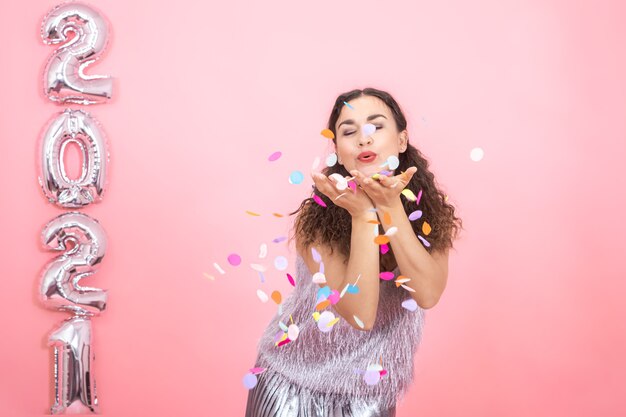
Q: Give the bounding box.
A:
[335,96,408,176]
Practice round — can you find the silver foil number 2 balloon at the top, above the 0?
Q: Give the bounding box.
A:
[41,2,113,104]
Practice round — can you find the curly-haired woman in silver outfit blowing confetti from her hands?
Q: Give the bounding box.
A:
[246,88,462,417]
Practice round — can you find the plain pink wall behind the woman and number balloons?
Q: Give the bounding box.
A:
[0,0,626,417]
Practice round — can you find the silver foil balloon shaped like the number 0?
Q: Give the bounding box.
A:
[38,109,110,208]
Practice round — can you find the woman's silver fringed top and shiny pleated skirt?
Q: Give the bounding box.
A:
[246,255,425,417]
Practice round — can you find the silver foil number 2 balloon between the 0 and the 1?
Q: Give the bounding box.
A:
[39,212,107,316]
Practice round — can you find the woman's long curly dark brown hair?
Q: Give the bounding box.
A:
[289,88,462,269]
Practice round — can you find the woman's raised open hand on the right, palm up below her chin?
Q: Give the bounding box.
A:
[350,167,417,207]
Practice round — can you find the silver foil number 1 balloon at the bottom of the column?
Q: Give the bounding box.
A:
[48,317,99,414]
